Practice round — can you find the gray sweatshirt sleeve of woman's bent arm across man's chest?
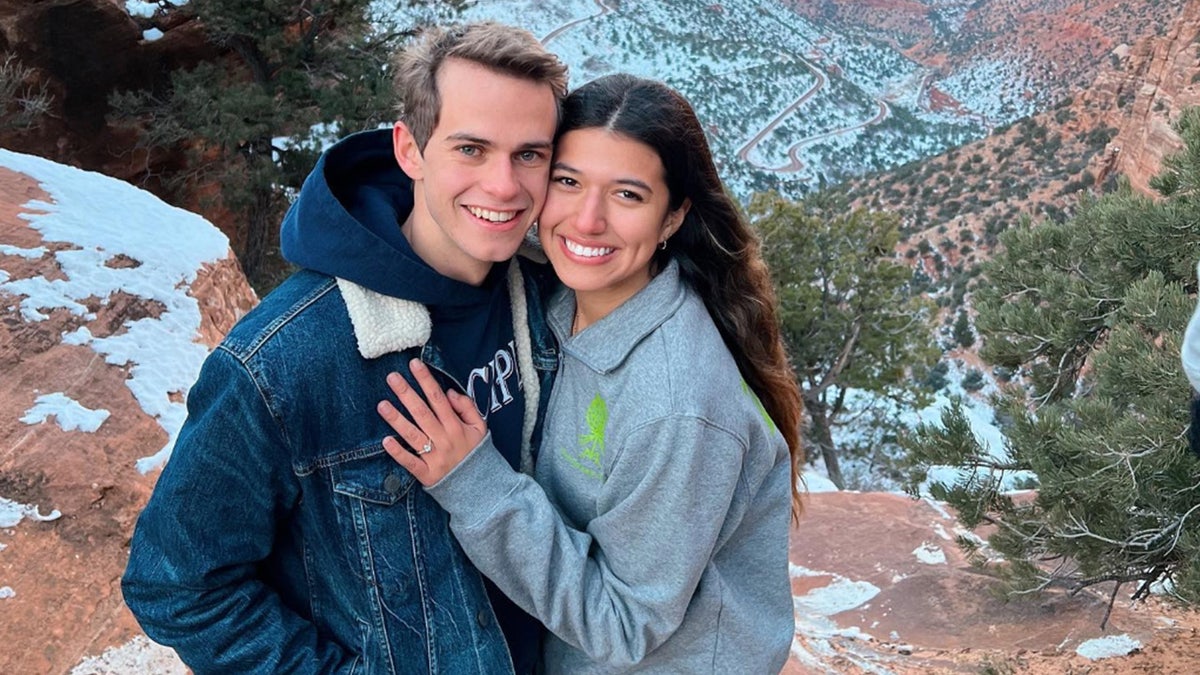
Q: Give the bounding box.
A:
[428,417,745,665]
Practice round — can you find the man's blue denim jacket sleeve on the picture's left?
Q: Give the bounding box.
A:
[121,348,354,675]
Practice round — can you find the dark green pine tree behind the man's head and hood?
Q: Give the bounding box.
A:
[112,0,408,291]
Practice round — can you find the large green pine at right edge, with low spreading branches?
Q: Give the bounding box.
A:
[907,109,1200,620]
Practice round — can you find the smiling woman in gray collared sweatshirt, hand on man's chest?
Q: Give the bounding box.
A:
[379,74,802,673]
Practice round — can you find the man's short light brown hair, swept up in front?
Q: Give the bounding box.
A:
[392,22,566,151]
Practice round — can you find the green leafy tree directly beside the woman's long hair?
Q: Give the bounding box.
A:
[749,193,940,488]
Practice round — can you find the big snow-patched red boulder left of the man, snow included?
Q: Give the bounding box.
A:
[0,150,257,673]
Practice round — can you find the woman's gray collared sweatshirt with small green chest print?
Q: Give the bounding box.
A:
[428,263,794,674]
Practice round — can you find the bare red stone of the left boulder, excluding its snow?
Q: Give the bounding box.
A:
[0,158,257,674]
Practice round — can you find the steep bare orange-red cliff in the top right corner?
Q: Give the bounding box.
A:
[1084,2,1200,193]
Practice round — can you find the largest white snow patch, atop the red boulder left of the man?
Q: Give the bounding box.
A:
[0,149,229,473]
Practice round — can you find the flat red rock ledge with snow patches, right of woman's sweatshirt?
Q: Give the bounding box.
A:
[784,492,1200,675]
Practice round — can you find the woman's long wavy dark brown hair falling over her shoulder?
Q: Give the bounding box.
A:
[558,74,804,518]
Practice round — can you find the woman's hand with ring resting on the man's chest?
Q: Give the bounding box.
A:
[376,359,487,488]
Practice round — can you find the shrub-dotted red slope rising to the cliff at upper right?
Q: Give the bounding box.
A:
[844,0,1200,265]
